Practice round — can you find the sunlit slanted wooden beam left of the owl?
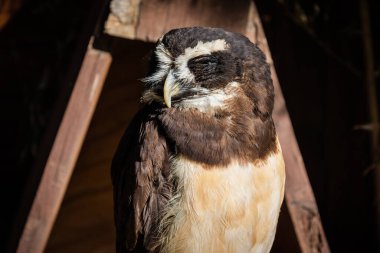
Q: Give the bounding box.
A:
[17,48,111,253]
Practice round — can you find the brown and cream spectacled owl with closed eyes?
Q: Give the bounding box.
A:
[111,27,285,253]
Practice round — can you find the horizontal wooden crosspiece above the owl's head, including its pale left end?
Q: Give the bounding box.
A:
[105,0,250,42]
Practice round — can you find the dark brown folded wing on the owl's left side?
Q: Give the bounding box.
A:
[111,106,172,253]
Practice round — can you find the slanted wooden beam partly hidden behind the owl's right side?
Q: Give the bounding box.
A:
[246,2,330,253]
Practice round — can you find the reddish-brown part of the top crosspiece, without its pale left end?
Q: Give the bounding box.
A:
[136,0,249,41]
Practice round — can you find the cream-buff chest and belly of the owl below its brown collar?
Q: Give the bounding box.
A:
[157,148,284,253]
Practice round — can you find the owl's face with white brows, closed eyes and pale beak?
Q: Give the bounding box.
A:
[143,27,270,110]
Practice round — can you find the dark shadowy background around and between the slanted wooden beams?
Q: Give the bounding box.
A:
[0,0,380,252]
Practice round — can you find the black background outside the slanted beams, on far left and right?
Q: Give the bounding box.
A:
[0,0,380,252]
